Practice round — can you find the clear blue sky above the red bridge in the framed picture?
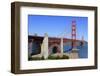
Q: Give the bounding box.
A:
[28,15,88,41]
